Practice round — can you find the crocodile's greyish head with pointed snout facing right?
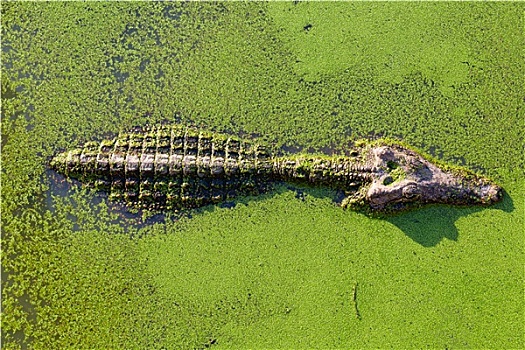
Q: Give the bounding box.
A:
[346,145,503,211]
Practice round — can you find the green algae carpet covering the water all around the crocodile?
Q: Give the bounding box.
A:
[1,2,525,349]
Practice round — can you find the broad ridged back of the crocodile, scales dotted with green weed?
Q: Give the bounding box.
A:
[55,125,273,210]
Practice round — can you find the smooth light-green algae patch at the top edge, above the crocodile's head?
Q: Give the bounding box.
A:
[269,2,475,89]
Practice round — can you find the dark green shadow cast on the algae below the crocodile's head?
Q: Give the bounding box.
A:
[384,187,514,247]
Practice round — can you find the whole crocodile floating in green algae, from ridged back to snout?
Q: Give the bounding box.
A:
[50,125,503,212]
